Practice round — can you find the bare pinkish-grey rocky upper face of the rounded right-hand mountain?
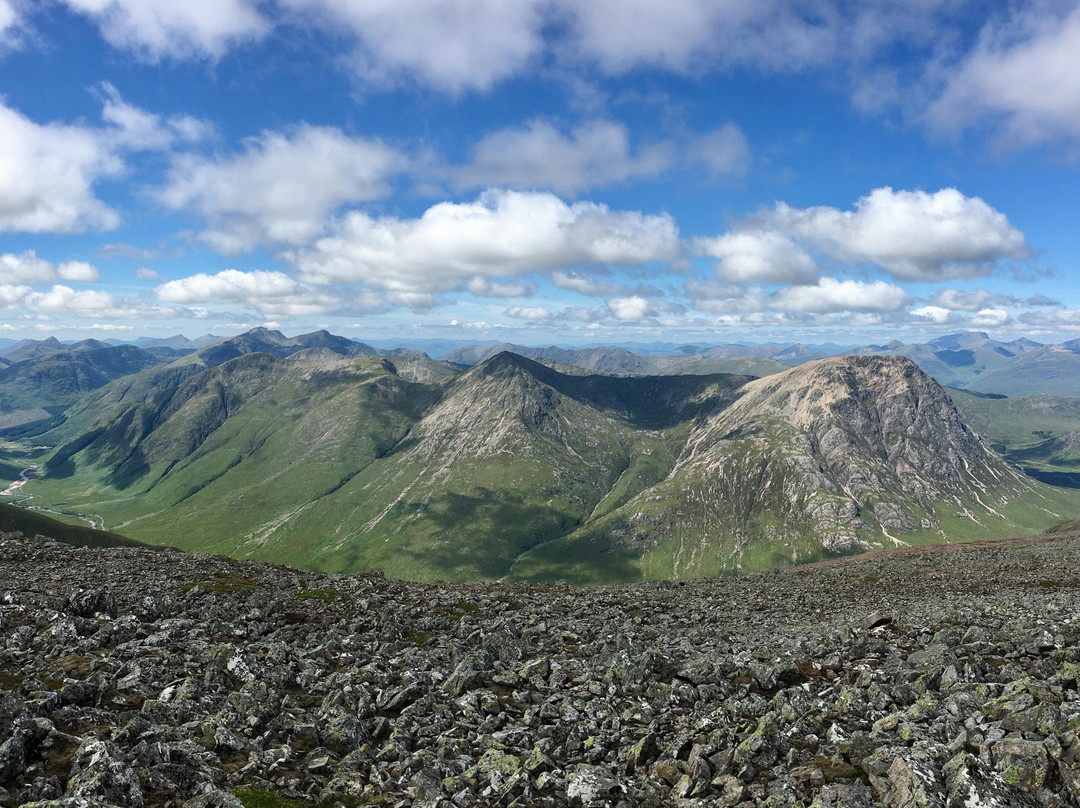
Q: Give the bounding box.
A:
[674,356,1028,551]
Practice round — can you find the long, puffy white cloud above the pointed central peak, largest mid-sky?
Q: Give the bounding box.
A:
[285,190,679,293]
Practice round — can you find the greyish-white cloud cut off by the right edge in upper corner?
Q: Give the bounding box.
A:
[927,3,1080,147]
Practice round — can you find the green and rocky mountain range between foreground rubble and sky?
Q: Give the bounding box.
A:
[9,329,1080,582]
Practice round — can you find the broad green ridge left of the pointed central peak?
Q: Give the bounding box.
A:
[33,351,435,552]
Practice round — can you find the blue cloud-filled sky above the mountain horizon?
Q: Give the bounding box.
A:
[0,0,1080,346]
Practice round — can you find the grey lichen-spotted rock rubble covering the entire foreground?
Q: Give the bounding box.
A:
[0,535,1080,808]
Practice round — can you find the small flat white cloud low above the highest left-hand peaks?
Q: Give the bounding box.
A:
[153,269,341,317]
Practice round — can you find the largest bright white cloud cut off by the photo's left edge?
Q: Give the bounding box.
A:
[0,103,123,233]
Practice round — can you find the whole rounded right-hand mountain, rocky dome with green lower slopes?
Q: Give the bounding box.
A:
[512,356,1080,581]
